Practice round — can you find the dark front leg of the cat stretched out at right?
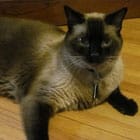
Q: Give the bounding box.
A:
[107,87,138,116]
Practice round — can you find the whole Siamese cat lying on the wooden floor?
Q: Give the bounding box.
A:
[0,6,138,140]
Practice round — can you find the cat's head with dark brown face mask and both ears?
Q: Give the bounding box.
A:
[65,7,127,64]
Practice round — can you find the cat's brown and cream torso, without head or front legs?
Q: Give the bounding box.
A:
[0,18,123,111]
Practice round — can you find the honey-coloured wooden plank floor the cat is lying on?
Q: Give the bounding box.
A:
[0,19,140,140]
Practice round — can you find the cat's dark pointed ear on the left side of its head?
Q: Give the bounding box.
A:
[64,6,85,29]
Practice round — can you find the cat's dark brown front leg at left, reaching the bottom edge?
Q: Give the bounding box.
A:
[21,97,52,140]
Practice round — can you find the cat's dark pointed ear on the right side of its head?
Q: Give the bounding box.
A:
[105,7,127,31]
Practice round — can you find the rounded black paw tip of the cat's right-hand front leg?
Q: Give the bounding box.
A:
[119,99,138,116]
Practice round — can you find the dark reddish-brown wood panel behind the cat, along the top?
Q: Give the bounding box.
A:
[0,0,140,25]
